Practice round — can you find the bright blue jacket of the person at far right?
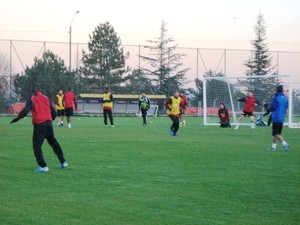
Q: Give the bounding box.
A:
[270,92,288,123]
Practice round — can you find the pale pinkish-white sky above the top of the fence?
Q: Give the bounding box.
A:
[0,0,300,52]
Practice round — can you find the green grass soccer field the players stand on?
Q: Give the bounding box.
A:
[0,117,300,225]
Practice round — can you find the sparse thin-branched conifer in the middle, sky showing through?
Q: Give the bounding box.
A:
[140,21,189,96]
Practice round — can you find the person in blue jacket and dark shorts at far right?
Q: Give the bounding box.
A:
[269,85,289,151]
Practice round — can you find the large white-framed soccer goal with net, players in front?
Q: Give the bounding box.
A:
[203,75,299,127]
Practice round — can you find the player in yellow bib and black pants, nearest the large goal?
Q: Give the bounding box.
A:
[165,91,181,136]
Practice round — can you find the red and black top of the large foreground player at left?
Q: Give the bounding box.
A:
[18,91,56,124]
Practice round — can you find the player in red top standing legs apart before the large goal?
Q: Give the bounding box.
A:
[235,91,258,129]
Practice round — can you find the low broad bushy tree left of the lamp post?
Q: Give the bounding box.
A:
[14,50,76,99]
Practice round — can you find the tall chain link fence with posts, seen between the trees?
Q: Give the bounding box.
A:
[0,39,300,112]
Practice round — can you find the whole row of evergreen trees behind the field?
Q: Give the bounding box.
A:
[0,13,292,110]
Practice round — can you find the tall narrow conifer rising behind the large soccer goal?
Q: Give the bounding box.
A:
[244,13,280,101]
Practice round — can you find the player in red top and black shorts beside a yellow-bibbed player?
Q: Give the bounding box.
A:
[63,87,77,128]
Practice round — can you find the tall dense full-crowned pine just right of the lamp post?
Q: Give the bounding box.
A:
[80,22,128,91]
